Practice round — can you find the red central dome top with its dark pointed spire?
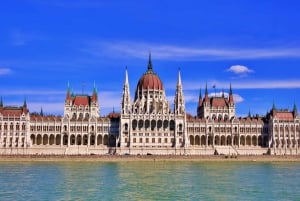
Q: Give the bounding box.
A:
[137,55,163,90]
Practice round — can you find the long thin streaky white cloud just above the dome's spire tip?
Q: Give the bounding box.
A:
[83,41,300,60]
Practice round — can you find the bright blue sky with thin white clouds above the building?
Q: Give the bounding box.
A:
[0,0,300,116]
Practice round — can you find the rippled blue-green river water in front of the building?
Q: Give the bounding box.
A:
[0,161,300,200]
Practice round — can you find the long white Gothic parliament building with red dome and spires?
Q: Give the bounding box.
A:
[0,55,300,155]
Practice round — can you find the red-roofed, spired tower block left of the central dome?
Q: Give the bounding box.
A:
[64,84,100,121]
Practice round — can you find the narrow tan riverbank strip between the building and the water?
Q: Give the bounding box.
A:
[0,155,300,162]
